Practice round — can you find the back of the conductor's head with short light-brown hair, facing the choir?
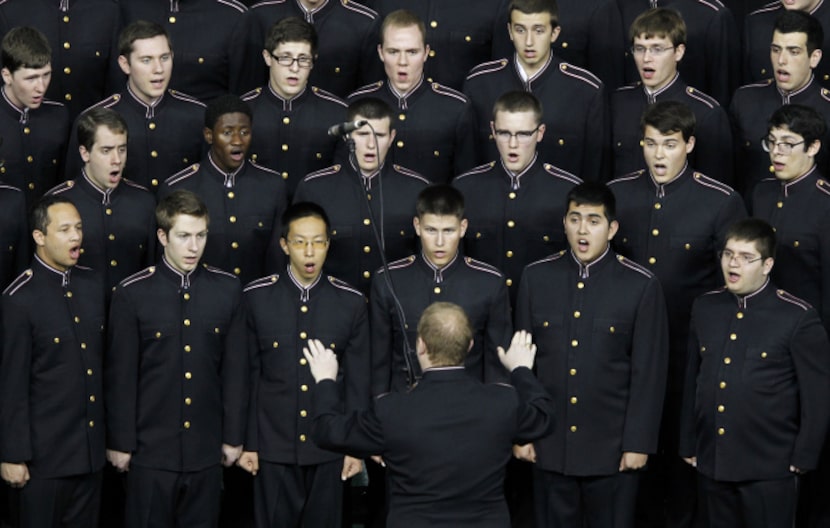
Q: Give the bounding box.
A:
[418,302,473,366]
